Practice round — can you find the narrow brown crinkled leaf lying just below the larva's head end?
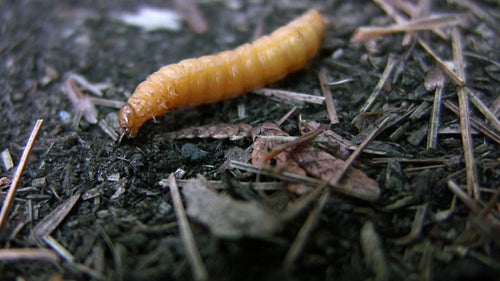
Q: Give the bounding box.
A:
[157,123,252,141]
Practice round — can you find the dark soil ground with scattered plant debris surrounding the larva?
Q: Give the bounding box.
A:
[0,0,500,280]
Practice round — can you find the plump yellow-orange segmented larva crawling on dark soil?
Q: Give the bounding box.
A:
[119,10,325,137]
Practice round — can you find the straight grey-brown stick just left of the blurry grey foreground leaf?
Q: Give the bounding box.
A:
[168,173,208,280]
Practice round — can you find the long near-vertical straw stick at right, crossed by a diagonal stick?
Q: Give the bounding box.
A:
[451,27,480,199]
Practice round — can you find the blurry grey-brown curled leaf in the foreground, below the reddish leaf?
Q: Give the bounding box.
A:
[182,177,282,239]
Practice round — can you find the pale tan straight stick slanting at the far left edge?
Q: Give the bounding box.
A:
[0,119,43,228]
